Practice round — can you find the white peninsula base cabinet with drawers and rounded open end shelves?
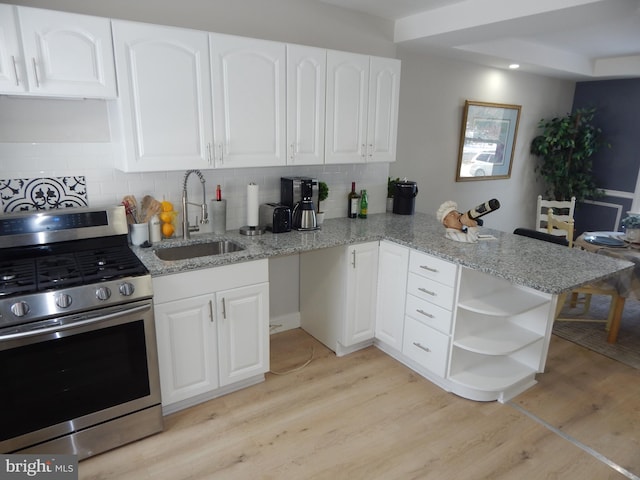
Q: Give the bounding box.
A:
[376,245,556,402]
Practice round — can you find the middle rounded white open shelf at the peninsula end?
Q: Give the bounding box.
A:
[453,322,544,355]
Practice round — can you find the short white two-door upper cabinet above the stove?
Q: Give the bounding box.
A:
[0,5,117,98]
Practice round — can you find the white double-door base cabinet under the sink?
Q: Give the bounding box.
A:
[153,260,269,414]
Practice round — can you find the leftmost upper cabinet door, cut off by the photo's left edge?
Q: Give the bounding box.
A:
[0,5,27,93]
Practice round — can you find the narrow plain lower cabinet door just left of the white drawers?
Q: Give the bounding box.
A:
[376,241,409,351]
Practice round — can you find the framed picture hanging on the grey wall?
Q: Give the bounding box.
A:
[456,100,522,182]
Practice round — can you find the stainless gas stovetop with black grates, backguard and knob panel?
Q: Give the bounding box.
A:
[0,206,153,329]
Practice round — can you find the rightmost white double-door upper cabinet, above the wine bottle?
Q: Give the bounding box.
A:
[325,50,400,163]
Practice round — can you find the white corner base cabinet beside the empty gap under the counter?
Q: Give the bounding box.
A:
[300,242,378,356]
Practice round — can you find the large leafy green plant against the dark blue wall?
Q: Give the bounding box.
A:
[531,108,608,201]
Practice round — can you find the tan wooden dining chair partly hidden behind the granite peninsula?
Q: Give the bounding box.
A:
[547,208,624,341]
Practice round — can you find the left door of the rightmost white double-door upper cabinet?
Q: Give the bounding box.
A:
[325,50,369,163]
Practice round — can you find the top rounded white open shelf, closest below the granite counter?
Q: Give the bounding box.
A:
[458,287,550,317]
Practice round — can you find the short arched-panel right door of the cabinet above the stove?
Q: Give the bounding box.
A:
[17,7,116,98]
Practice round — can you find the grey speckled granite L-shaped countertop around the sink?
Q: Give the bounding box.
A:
[132,213,633,294]
